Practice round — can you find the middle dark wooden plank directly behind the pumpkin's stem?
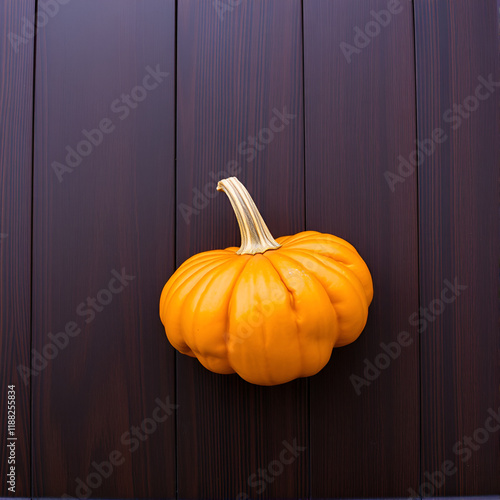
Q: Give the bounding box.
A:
[177,0,309,499]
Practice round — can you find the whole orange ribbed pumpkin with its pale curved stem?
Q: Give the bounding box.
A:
[160,177,373,385]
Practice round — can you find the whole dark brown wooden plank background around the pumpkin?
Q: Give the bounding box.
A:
[0,0,500,499]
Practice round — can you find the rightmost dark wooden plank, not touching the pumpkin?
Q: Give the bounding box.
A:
[415,0,500,496]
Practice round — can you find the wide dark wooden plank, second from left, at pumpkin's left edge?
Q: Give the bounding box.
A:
[31,0,175,498]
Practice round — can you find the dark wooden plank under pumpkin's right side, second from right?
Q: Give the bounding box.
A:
[304,0,420,498]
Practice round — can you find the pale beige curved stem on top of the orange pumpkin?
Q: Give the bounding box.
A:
[217,177,281,255]
